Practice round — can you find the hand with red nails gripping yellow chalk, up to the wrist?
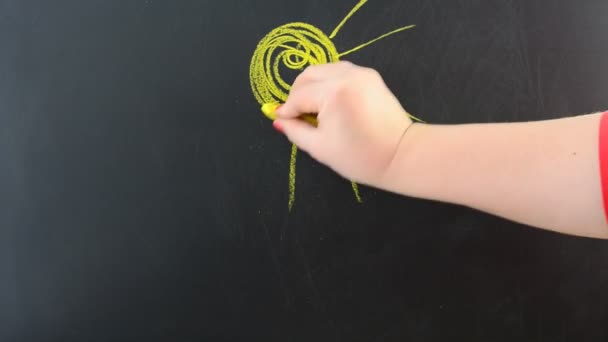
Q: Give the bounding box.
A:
[274,62,412,186]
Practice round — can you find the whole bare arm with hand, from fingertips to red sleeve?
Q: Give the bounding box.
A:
[274,62,608,238]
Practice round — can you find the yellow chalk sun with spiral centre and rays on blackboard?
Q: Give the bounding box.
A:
[249,0,415,210]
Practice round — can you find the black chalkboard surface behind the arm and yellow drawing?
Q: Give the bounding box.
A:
[0,0,608,342]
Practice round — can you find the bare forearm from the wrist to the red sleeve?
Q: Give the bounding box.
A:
[381,115,608,238]
